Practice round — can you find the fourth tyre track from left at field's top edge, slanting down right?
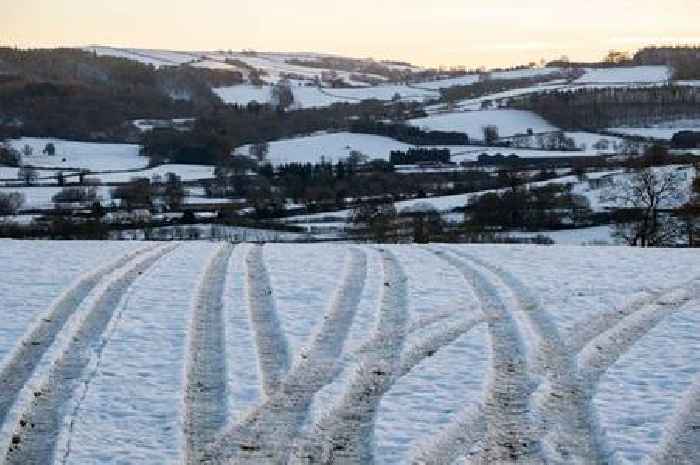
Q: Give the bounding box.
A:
[246,245,290,397]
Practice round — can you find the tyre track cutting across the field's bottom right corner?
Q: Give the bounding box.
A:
[649,377,700,465]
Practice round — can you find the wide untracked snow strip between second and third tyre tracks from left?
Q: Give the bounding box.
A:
[65,243,212,465]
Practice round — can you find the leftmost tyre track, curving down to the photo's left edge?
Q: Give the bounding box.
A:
[0,247,152,436]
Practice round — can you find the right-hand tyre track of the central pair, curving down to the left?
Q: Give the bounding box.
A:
[291,250,408,465]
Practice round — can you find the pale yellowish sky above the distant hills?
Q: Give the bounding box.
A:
[0,0,700,67]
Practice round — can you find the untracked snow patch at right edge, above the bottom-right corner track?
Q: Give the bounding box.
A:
[594,301,700,465]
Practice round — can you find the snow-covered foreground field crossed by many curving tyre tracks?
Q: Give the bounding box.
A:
[0,241,700,465]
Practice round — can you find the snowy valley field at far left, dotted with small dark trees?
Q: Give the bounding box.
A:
[9,137,148,171]
